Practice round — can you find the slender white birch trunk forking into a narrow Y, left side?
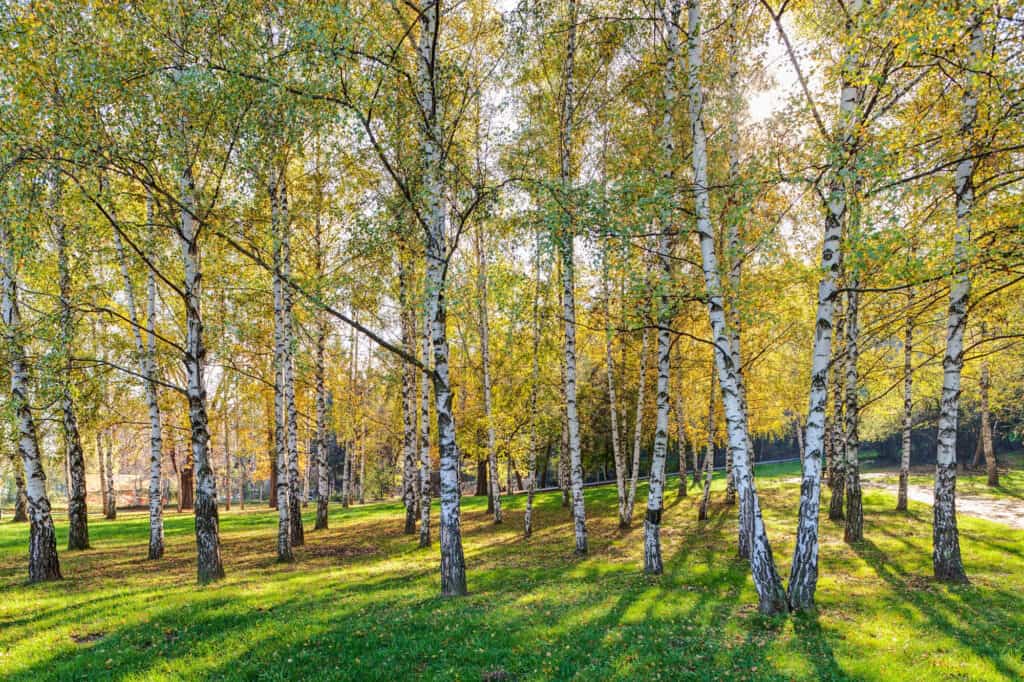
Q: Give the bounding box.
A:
[114,196,164,560]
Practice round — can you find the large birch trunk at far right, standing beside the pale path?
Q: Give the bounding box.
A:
[932,14,983,583]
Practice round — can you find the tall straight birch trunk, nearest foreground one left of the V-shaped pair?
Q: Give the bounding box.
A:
[643,0,682,576]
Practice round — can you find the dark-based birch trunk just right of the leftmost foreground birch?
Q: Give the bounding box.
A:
[49,168,89,550]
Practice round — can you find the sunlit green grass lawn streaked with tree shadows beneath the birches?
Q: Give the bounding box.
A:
[0,465,1024,680]
